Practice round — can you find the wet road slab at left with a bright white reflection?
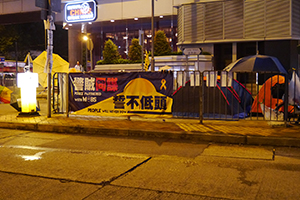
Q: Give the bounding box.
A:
[0,145,148,185]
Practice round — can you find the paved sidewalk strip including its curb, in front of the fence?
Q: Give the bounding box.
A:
[0,99,300,147]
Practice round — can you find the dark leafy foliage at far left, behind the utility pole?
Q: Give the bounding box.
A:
[0,21,68,60]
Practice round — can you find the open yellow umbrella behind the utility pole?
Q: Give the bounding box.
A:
[33,51,69,88]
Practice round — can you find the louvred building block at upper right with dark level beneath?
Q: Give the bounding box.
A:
[177,0,300,70]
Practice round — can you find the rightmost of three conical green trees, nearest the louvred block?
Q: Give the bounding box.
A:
[154,31,172,56]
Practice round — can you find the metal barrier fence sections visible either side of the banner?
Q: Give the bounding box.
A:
[52,71,300,123]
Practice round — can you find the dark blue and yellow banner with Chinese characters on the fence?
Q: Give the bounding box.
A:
[69,72,173,117]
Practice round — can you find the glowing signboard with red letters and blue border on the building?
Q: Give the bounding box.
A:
[65,0,97,23]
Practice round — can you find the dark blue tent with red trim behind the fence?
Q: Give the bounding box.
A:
[172,78,253,119]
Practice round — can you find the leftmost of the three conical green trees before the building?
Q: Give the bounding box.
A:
[103,39,121,63]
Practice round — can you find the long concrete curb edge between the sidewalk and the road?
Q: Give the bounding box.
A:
[0,122,300,147]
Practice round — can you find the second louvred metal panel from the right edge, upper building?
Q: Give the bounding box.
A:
[265,0,290,38]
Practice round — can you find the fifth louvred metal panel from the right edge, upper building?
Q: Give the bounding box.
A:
[205,2,223,40]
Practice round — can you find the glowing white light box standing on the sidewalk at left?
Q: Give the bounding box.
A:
[17,72,39,113]
